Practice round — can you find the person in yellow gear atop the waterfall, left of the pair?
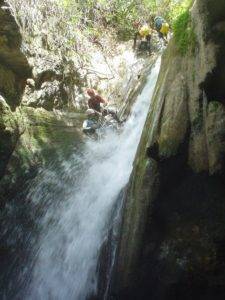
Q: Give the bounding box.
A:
[133,22,152,51]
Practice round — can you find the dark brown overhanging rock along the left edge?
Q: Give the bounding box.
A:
[0,1,31,178]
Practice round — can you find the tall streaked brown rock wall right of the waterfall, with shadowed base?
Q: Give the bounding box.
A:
[114,0,225,300]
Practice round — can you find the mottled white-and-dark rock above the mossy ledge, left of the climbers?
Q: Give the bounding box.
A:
[22,53,81,111]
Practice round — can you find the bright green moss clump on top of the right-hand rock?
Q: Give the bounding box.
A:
[173,9,196,55]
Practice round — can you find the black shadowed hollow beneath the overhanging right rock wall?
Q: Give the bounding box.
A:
[135,171,225,300]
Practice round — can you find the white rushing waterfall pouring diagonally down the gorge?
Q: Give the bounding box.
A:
[25,59,160,300]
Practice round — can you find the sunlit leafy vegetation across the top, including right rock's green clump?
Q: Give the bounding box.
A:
[6,0,193,55]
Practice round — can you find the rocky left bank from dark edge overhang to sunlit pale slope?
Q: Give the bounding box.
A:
[0,0,151,202]
